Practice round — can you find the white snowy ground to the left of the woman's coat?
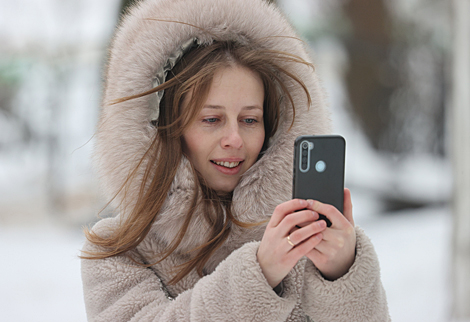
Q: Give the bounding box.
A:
[0,225,86,322]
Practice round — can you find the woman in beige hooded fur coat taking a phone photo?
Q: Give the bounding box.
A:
[82,0,389,321]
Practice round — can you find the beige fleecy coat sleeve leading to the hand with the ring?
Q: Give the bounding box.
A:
[82,226,303,322]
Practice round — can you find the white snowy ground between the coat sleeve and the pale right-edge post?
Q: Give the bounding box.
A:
[356,208,452,322]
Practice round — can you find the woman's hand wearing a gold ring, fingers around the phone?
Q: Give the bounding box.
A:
[257,199,326,288]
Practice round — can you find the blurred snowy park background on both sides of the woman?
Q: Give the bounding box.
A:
[0,0,470,322]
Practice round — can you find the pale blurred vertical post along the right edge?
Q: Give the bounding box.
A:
[451,0,470,321]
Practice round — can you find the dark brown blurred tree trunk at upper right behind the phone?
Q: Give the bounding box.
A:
[344,0,398,149]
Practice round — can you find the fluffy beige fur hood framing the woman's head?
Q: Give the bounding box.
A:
[95,0,331,271]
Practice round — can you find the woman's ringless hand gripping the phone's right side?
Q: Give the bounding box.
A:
[306,189,356,281]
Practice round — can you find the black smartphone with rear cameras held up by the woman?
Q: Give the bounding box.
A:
[292,135,346,227]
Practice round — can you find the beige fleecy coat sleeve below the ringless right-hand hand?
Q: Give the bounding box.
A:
[302,227,390,322]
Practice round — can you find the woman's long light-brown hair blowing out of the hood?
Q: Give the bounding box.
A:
[82,41,313,284]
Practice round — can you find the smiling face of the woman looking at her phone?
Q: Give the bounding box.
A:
[183,66,264,192]
